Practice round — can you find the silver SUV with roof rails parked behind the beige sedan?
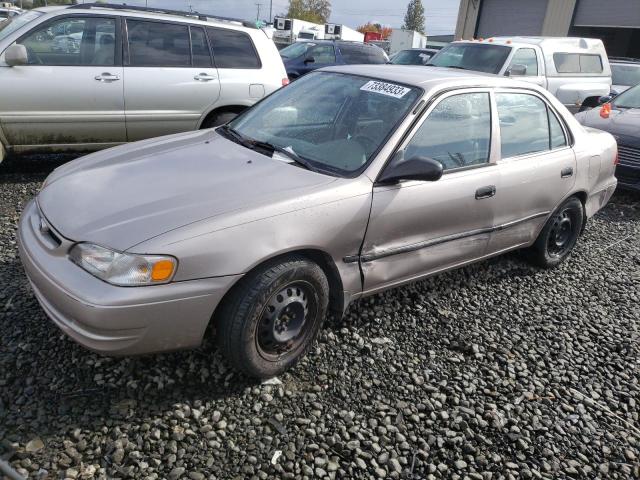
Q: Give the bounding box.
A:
[0,4,288,160]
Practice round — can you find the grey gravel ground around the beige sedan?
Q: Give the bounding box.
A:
[0,158,640,480]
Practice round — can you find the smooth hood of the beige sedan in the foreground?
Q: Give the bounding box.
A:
[38,130,335,251]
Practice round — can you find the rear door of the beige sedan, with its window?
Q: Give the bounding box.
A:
[489,90,576,253]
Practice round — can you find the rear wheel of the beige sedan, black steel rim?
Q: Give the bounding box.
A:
[527,197,584,268]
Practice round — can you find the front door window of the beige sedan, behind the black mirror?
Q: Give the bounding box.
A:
[404,93,491,170]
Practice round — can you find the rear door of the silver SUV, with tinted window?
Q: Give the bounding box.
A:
[124,18,220,141]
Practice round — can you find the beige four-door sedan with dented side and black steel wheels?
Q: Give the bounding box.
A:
[18,65,622,377]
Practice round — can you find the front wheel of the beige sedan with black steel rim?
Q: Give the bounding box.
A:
[215,256,329,378]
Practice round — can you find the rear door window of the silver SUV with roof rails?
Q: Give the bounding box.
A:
[127,19,191,67]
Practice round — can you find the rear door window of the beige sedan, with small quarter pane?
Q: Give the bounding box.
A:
[496,93,567,158]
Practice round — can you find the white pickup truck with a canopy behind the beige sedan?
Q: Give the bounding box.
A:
[429,37,611,112]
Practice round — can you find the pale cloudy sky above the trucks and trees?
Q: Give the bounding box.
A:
[116,0,460,35]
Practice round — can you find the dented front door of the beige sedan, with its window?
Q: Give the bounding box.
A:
[361,90,499,292]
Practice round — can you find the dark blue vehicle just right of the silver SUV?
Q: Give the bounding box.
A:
[280,40,389,80]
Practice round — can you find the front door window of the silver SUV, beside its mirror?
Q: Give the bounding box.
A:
[18,17,116,66]
